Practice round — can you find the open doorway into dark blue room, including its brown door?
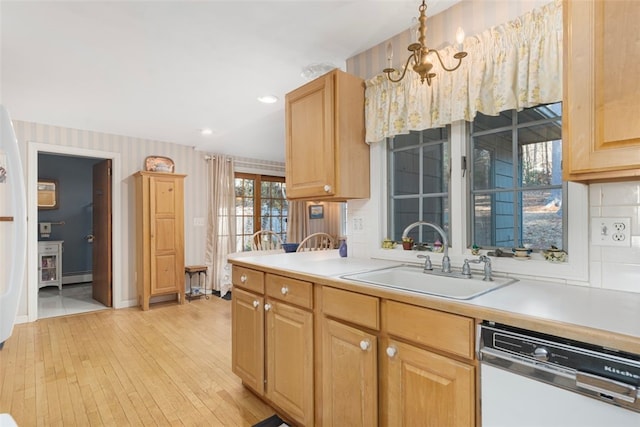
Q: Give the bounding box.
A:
[38,152,112,319]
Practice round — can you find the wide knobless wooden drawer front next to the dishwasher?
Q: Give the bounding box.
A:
[382,301,474,359]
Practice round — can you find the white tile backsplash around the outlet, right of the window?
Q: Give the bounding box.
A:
[589,181,640,292]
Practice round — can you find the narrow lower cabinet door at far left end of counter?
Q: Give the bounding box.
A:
[231,287,264,395]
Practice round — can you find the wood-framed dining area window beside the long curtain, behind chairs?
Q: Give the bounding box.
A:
[235,173,288,251]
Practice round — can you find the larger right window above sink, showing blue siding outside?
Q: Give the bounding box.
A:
[469,103,566,249]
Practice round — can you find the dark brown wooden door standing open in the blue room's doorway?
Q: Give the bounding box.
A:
[92,159,113,307]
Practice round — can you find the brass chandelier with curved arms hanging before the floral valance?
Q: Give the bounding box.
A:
[382,0,467,86]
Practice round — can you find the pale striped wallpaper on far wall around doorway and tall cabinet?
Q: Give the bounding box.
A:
[13,121,284,316]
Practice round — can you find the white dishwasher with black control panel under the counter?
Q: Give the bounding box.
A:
[478,322,640,427]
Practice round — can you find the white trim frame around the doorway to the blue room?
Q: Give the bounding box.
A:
[27,142,122,321]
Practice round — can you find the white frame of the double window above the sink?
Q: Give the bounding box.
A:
[370,120,597,285]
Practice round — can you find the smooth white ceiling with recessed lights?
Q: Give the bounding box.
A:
[0,0,459,161]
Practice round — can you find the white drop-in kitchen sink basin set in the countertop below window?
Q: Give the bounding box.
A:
[342,265,517,300]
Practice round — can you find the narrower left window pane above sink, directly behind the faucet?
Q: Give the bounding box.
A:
[388,127,450,244]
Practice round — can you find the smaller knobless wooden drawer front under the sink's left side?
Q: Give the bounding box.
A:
[322,286,380,331]
